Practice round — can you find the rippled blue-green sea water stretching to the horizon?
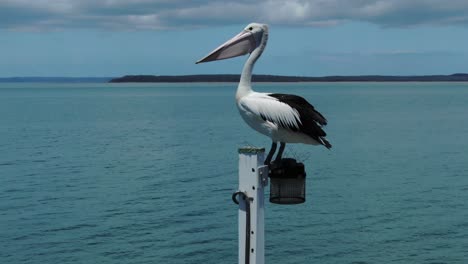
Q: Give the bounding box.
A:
[0,83,468,264]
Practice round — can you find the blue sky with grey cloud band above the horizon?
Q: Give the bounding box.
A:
[0,0,468,77]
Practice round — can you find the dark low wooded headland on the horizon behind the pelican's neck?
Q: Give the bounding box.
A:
[109,73,468,83]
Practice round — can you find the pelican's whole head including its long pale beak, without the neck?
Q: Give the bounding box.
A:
[197,23,268,63]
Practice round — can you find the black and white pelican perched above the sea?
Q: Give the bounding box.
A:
[196,23,331,165]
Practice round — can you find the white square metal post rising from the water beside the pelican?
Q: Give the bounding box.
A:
[238,147,268,264]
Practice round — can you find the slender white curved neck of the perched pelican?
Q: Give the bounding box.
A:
[236,27,268,100]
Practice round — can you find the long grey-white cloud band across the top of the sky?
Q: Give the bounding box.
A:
[0,0,468,30]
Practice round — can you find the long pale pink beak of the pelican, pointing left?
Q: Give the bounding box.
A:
[196,30,257,64]
